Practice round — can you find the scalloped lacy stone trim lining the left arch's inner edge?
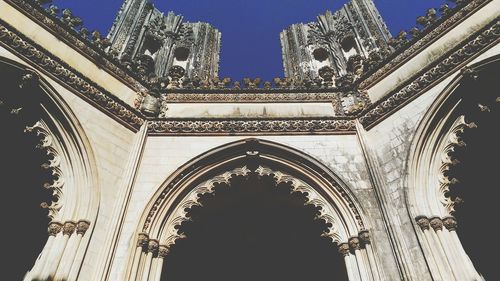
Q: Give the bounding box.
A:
[25,118,64,220]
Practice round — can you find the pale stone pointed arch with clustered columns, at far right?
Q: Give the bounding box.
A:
[405,55,500,280]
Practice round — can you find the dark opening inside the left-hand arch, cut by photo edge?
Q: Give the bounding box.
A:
[0,62,52,280]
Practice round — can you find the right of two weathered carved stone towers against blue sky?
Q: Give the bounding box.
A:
[280,0,391,80]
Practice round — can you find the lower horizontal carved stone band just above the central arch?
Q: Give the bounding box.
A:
[148,118,356,136]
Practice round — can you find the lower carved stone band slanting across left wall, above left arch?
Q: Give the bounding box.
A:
[0,20,144,129]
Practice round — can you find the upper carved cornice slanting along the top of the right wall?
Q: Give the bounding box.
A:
[359,0,491,89]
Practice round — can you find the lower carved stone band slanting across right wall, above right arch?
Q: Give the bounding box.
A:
[359,21,500,127]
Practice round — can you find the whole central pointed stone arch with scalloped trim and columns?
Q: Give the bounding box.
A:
[127,139,380,281]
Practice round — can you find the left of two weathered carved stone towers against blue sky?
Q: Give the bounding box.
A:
[108,0,221,80]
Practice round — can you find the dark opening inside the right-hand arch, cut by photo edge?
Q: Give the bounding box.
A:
[449,62,500,280]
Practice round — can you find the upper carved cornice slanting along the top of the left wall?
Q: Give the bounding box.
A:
[5,0,146,91]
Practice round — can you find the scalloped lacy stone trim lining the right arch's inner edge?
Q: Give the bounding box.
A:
[437,115,476,214]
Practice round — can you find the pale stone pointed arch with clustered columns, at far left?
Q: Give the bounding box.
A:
[0,57,99,280]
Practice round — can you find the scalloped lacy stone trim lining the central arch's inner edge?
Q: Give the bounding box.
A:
[158,166,348,248]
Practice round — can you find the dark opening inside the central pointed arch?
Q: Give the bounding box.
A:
[162,173,347,281]
